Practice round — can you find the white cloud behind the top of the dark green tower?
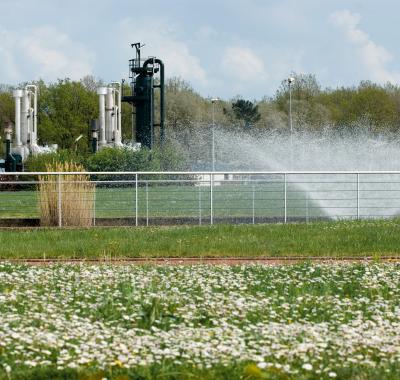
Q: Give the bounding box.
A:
[119,18,207,86]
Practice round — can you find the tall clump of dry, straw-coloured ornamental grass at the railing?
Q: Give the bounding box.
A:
[39,162,95,227]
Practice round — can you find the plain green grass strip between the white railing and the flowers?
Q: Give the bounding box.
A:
[0,219,400,259]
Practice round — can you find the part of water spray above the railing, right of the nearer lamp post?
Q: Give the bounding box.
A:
[215,130,400,171]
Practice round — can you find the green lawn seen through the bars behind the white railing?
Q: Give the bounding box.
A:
[0,182,328,219]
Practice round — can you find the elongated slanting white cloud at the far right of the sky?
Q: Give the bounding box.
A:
[331,10,400,83]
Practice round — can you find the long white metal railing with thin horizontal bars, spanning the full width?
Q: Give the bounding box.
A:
[0,171,400,227]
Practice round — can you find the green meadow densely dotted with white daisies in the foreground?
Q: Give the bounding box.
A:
[0,263,400,380]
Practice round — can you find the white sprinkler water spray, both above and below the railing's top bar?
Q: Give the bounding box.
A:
[175,129,400,218]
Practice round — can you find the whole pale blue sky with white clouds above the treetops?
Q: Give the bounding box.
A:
[0,0,400,100]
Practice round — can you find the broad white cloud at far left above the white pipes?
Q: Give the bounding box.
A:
[0,26,94,83]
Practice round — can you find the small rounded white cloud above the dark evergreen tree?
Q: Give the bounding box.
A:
[221,47,268,81]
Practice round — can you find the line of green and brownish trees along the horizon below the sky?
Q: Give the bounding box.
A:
[0,74,400,156]
